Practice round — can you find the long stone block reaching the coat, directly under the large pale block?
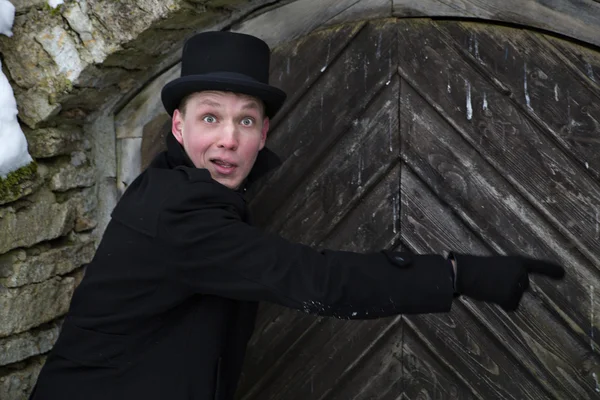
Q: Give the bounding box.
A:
[0,234,96,287]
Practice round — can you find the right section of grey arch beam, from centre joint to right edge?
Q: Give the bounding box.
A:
[393,0,600,46]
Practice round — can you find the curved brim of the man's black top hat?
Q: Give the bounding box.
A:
[161,74,286,118]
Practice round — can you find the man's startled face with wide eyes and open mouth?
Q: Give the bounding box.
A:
[172,91,269,189]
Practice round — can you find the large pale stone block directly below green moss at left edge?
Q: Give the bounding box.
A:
[0,188,76,255]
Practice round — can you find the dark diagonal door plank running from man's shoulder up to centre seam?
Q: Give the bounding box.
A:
[269,74,400,244]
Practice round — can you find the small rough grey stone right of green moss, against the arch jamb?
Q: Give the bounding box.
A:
[50,152,96,192]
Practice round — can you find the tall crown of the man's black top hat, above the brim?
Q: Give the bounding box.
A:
[181,31,270,84]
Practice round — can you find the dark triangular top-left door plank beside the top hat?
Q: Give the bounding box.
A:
[269,23,364,130]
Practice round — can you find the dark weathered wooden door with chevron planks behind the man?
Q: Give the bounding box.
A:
[238,19,600,400]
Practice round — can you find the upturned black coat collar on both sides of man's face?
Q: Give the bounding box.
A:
[156,132,281,190]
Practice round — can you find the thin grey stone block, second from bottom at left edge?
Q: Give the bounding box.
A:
[0,320,62,366]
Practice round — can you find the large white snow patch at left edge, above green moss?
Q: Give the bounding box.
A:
[0,62,33,178]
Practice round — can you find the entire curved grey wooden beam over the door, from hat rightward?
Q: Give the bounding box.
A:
[232,0,600,46]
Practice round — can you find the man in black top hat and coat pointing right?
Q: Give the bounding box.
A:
[32,32,564,400]
